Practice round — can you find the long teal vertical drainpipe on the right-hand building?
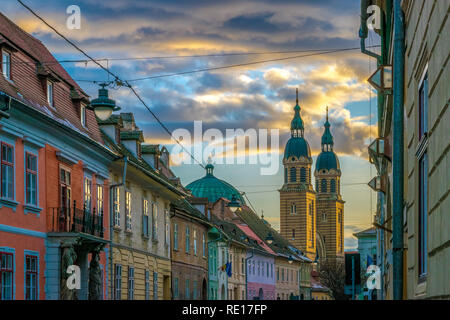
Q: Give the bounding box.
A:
[392,0,405,300]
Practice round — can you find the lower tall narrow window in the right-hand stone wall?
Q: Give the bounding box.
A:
[418,153,428,278]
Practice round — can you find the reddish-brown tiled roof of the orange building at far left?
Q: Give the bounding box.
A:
[0,13,103,143]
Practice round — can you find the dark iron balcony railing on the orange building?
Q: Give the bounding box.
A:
[49,201,104,238]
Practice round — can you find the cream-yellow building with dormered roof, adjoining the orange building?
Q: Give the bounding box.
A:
[99,113,182,300]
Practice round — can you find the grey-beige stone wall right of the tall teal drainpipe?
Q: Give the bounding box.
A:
[403,0,450,299]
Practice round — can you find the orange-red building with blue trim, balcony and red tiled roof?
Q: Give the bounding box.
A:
[0,14,114,300]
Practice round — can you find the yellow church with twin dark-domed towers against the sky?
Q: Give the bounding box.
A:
[279,89,344,262]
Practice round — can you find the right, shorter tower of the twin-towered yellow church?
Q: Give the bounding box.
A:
[314,107,344,262]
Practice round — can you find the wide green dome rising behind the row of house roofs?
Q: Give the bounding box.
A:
[186,164,245,205]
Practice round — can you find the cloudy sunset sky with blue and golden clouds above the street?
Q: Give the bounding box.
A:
[2,0,377,249]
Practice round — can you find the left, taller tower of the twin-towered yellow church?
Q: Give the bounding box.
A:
[279,89,316,259]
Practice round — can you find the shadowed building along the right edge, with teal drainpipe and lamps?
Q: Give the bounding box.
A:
[360,0,450,299]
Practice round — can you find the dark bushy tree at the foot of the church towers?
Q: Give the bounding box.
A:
[319,262,348,300]
